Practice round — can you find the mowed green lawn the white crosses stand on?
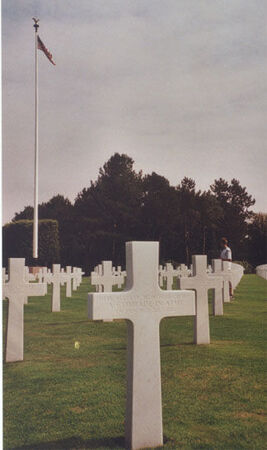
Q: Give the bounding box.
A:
[3,275,267,450]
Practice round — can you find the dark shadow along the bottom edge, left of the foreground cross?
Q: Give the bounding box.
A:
[13,436,125,450]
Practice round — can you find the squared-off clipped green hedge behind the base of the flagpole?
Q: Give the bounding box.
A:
[3,219,60,267]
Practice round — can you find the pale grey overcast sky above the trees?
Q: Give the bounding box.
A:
[2,0,267,222]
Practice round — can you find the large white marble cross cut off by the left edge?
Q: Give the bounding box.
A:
[3,258,46,362]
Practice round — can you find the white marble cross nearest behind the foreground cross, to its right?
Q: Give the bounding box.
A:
[178,255,224,344]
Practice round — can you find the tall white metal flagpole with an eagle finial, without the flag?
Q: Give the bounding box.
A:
[32,18,39,258]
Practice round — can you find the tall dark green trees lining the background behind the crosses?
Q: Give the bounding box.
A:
[8,153,267,273]
